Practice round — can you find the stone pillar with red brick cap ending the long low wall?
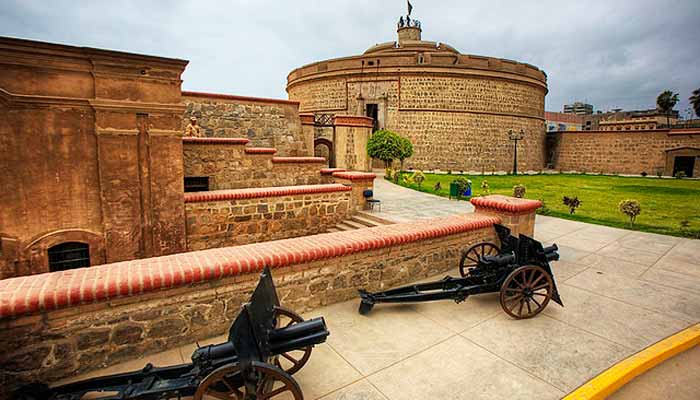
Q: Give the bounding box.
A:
[471,194,542,237]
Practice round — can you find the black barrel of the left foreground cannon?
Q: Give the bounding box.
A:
[269,317,329,354]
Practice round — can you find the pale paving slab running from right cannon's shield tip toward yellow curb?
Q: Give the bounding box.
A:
[544,284,688,350]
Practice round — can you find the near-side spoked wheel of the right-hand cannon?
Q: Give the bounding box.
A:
[501,265,554,319]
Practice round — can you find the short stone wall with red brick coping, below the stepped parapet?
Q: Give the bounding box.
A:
[185,184,352,250]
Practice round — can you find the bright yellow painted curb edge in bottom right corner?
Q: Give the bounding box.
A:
[563,324,700,400]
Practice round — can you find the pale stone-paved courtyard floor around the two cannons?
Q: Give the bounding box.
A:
[56,183,700,400]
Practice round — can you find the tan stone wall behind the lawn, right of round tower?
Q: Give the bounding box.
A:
[553,129,700,176]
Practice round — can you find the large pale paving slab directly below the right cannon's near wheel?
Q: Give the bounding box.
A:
[462,314,633,392]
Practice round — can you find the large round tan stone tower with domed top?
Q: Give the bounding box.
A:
[287,17,547,172]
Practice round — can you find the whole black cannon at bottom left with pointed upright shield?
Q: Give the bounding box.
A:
[16,267,329,400]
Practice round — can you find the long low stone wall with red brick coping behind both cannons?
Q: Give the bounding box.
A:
[0,209,508,397]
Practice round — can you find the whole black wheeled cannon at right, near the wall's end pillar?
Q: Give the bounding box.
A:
[359,224,564,319]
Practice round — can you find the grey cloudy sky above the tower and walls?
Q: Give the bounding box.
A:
[0,0,700,115]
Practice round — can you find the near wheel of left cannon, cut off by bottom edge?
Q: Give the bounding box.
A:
[192,361,304,400]
